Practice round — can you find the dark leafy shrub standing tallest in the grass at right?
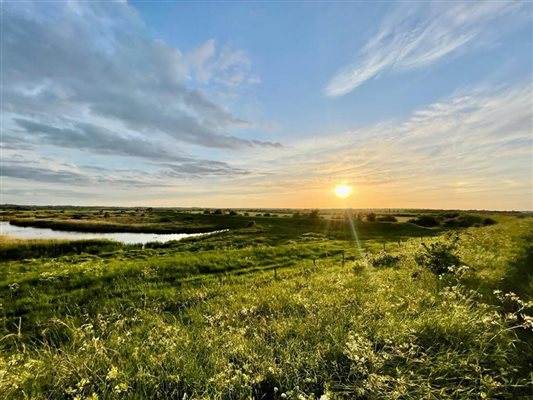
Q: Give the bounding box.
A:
[415,236,461,275]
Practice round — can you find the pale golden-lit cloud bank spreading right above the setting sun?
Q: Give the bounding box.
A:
[235,82,533,209]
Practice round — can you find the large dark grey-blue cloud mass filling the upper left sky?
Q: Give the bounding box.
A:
[1,2,275,149]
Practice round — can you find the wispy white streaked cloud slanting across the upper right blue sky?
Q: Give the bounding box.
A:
[324,1,528,97]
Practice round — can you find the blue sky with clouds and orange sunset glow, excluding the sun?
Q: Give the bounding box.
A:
[0,0,533,210]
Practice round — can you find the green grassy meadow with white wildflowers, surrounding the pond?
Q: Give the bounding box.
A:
[0,207,533,400]
